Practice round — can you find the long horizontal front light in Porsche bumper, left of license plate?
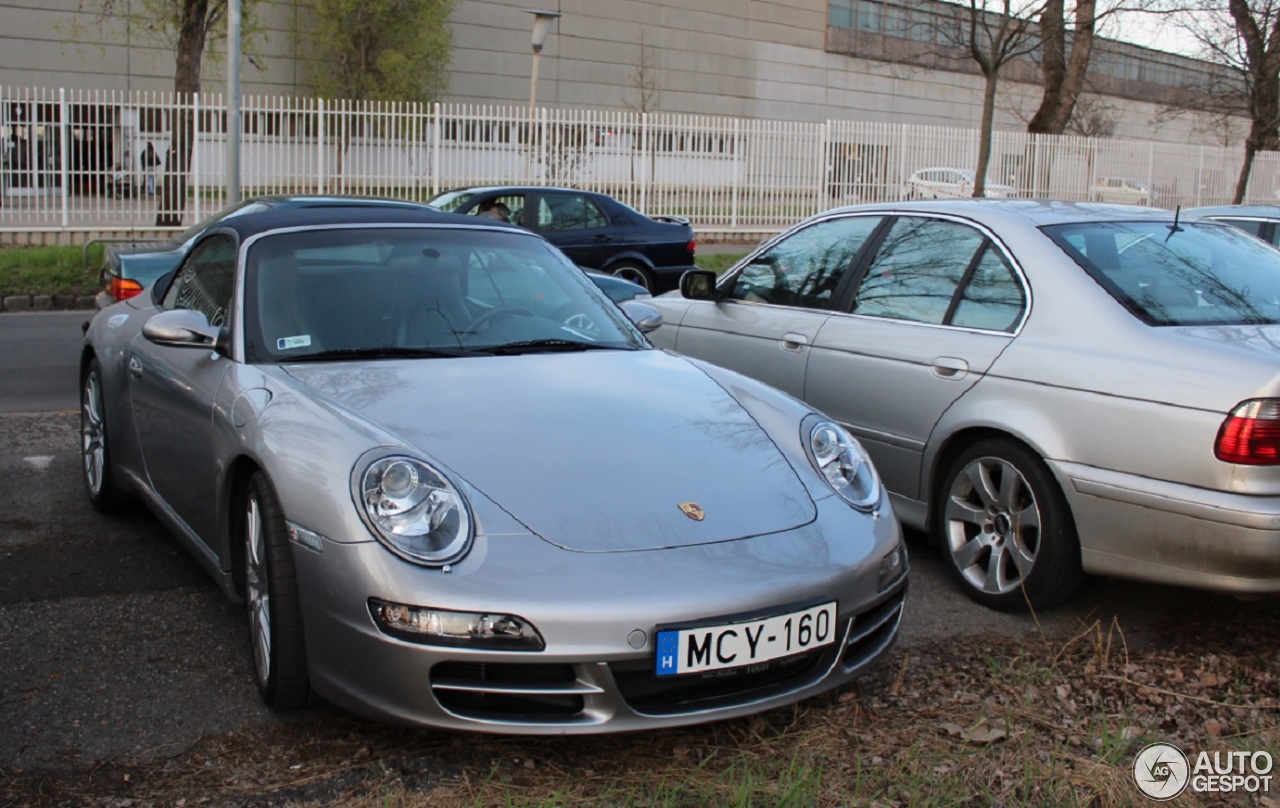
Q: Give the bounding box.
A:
[369,598,547,650]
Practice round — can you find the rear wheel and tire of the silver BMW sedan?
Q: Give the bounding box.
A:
[934,438,1084,611]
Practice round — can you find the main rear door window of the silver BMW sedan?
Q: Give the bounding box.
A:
[854,216,986,324]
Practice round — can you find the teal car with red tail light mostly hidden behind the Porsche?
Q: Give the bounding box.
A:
[97,195,650,309]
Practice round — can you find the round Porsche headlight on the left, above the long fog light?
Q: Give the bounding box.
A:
[360,456,471,566]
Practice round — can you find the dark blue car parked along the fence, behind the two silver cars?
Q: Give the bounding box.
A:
[428,186,698,292]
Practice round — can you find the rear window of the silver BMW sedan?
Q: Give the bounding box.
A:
[1044,222,1280,325]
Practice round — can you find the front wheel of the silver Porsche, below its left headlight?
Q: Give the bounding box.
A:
[239,471,310,709]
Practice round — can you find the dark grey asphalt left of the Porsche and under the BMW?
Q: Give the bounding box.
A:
[0,314,1280,771]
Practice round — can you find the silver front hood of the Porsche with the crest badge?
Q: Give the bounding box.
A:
[285,351,817,552]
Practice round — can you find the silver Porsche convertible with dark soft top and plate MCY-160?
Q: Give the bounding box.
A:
[81,206,908,734]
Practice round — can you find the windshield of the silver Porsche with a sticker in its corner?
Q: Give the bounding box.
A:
[244,227,648,362]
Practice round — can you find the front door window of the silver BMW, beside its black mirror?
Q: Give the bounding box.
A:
[730,216,883,309]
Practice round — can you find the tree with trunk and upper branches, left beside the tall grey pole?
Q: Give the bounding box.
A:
[78,0,257,227]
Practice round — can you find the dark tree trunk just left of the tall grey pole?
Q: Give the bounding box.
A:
[156,0,212,227]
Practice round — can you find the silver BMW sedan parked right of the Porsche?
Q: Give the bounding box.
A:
[653,200,1280,608]
